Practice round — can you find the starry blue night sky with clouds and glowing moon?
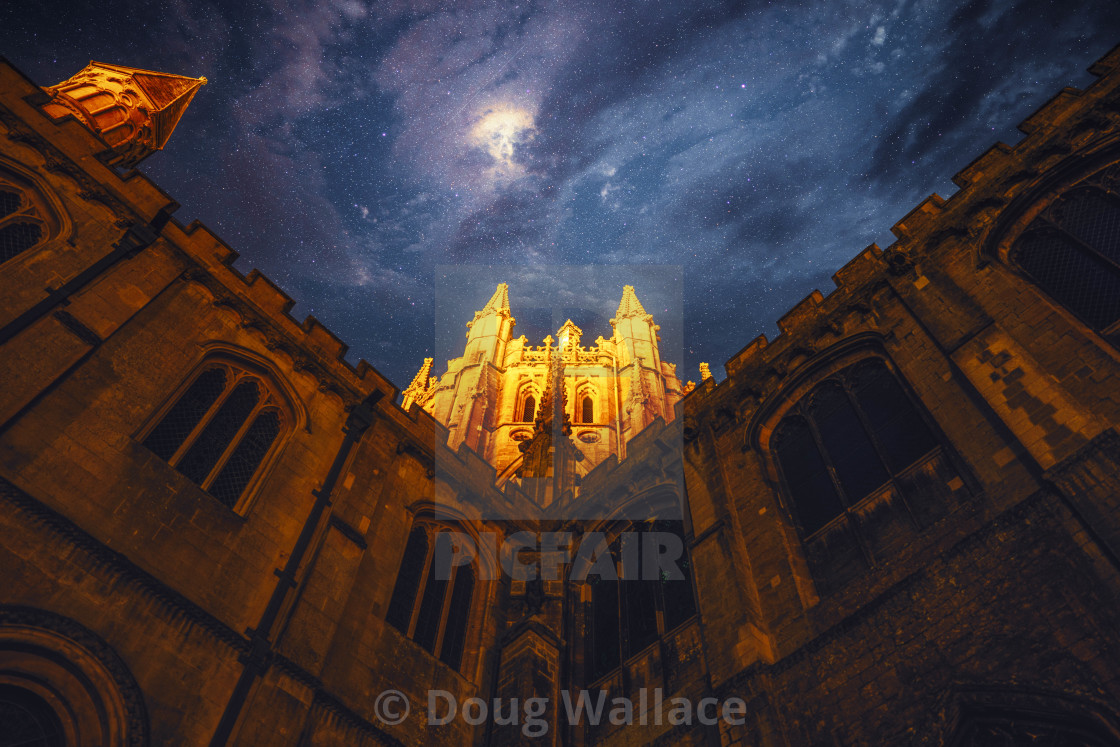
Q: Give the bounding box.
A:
[0,0,1120,386]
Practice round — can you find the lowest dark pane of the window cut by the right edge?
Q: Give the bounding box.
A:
[1014,230,1120,329]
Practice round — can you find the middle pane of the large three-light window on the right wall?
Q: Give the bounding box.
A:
[809,382,889,503]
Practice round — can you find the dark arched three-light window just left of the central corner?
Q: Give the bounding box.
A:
[385,523,475,669]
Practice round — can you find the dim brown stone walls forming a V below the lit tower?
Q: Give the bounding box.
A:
[0,43,1120,746]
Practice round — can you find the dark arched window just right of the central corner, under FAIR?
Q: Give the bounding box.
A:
[586,521,696,681]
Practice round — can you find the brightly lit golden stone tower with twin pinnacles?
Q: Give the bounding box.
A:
[402,283,682,490]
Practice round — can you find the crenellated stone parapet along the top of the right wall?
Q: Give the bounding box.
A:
[698,42,1120,409]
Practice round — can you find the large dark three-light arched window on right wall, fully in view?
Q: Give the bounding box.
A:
[771,358,939,535]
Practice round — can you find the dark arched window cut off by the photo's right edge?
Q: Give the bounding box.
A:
[1010,181,1120,333]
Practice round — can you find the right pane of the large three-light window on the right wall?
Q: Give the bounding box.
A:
[850,360,937,475]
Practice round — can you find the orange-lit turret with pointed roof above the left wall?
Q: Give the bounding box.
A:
[44,60,206,167]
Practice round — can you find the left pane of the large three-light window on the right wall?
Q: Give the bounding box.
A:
[774,417,843,534]
